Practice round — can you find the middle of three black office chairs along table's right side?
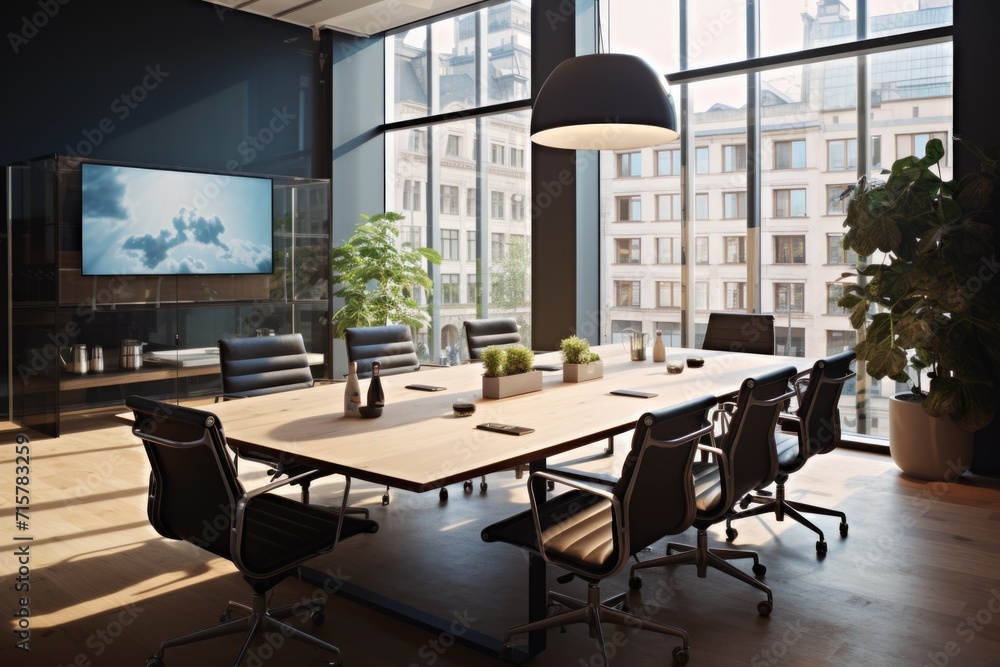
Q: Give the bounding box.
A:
[629,366,795,616]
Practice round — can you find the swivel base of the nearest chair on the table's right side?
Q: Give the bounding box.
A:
[500,583,689,667]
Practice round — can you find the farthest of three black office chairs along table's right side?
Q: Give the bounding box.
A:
[726,350,855,556]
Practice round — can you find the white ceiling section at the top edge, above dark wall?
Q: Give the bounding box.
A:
[205,0,482,35]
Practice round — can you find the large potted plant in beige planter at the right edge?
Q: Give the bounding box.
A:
[838,139,1000,479]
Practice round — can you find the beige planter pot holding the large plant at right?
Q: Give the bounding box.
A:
[889,396,972,482]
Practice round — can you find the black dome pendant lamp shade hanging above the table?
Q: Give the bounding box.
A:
[531,53,677,150]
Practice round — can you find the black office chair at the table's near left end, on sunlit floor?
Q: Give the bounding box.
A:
[125,396,378,667]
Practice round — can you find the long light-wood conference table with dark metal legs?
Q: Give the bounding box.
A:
[123,344,807,660]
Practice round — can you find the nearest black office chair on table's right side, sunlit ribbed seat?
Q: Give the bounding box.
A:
[482,396,717,665]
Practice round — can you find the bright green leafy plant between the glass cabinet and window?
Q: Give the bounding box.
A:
[331,212,441,338]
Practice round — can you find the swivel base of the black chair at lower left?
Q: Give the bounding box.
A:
[146,594,342,667]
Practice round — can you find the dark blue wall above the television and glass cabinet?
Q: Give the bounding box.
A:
[0,0,320,178]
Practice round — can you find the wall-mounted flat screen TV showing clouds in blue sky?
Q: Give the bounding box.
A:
[81,163,274,276]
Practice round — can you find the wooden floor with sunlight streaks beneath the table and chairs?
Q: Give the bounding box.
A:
[0,413,1000,667]
